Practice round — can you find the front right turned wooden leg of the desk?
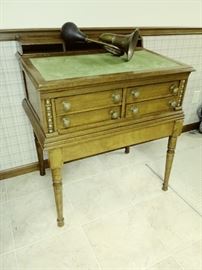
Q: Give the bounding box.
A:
[162,136,177,191]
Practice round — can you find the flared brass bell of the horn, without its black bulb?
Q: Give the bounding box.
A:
[99,29,139,61]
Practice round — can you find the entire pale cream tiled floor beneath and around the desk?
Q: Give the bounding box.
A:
[0,132,202,270]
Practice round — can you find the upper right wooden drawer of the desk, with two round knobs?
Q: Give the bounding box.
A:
[126,81,179,103]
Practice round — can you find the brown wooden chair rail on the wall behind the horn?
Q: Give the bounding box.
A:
[0,26,202,41]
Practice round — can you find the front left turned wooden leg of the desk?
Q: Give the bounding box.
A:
[49,149,64,227]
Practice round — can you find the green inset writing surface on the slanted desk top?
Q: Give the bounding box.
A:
[30,50,181,81]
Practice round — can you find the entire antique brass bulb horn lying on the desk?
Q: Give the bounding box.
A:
[61,22,139,61]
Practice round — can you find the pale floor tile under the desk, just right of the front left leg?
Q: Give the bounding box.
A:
[64,168,131,224]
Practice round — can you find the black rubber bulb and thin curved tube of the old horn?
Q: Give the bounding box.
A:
[61,22,124,56]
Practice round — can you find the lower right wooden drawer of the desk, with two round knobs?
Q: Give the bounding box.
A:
[126,97,177,118]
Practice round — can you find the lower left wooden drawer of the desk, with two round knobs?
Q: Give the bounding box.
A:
[57,106,121,129]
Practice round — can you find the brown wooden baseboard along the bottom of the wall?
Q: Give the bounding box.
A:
[0,122,199,180]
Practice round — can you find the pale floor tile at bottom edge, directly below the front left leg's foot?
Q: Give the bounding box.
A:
[17,229,100,270]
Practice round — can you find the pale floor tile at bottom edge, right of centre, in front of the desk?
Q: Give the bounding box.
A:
[84,208,167,270]
